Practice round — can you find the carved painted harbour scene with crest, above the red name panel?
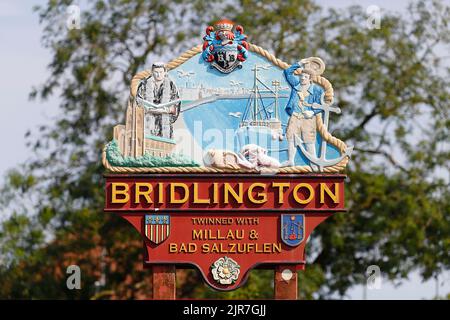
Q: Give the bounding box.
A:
[103,19,352,173]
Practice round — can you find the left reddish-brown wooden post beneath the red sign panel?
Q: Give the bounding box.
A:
[153,265,176,300]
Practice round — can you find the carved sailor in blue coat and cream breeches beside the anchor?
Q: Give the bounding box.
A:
[282,59,324,167]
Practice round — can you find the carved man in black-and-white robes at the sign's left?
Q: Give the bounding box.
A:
[137,62,181,139]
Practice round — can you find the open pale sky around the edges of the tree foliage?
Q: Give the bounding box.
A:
[0,0,450,299]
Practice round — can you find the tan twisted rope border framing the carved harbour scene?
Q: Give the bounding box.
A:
[102,44,349,173]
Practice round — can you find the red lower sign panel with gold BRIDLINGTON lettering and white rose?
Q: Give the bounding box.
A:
[105,175,345,290]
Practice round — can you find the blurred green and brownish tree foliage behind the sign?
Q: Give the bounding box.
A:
[0,0,450,299]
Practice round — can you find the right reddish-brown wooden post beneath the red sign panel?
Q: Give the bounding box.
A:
[274,265,298,300]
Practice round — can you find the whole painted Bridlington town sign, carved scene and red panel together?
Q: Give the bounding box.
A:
[102,19,353,297]
